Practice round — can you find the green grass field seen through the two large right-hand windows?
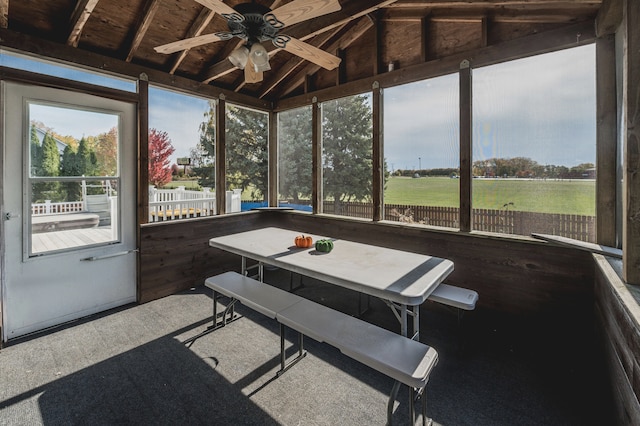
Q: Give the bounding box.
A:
[384,177,595,216]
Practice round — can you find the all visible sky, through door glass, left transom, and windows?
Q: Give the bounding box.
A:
[0,45,596,170]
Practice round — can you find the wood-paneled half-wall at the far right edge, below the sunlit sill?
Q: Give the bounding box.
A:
[594,255,640,425]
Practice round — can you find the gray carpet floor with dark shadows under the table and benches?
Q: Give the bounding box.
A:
[0,271,602,425]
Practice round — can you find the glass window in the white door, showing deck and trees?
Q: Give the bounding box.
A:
[25,102,120,256]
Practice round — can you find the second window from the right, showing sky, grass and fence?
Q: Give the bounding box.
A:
[383,74,460,228]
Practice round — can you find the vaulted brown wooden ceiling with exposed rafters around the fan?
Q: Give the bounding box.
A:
[0,0,603,100]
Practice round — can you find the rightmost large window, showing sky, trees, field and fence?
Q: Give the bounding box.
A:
[472,45,596,242]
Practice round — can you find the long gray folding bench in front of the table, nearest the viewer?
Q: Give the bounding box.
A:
[205,272,438,424]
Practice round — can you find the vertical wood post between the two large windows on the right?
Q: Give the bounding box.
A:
[459,60,473,232]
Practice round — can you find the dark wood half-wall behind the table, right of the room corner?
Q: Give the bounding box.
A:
[264,211,594,344]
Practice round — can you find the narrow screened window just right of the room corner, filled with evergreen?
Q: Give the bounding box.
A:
[278,107,313,211]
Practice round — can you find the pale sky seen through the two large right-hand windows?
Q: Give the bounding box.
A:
[383,45,596,170]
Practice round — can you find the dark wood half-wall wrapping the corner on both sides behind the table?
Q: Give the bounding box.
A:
[151,211,594,347]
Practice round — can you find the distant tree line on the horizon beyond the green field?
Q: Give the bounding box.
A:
[394,157,595,179]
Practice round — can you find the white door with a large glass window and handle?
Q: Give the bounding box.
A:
[0,82,137,341]
